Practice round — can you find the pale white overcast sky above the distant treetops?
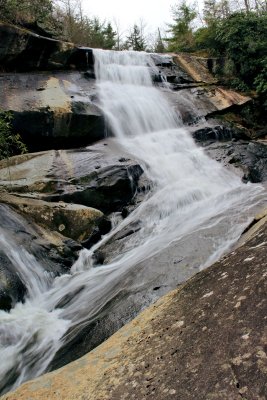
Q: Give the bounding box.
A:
[82,0,178,31]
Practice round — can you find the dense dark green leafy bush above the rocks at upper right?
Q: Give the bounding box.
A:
[194,8,267,97]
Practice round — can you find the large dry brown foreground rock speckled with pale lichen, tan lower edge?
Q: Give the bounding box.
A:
[2,217,267,400]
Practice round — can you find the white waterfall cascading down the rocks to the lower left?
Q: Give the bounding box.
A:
[0,50,262,392]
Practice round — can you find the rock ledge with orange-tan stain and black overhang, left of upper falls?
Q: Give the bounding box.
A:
[0,72,105,151]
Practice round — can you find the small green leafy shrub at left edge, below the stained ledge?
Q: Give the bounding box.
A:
[0,111,27,160]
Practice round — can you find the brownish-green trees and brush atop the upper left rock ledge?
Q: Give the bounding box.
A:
[0,0,116,49]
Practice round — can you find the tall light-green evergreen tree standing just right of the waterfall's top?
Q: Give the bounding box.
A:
[166,1,196,51]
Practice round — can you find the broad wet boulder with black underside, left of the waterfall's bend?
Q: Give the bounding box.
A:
[0,142,143,213]
